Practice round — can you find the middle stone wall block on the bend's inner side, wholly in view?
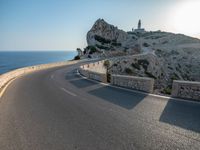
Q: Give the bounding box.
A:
[111,75,154,93]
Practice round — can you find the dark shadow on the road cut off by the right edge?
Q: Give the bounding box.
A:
[159,99,200,133]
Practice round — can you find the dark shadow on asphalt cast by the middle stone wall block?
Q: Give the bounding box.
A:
[88,87,147,109]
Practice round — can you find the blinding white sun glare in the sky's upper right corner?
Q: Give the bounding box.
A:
[172,1,200,34]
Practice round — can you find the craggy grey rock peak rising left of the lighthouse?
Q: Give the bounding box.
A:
[87,19,137,56]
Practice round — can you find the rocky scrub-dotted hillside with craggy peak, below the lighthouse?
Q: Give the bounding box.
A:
[81,19,200,94]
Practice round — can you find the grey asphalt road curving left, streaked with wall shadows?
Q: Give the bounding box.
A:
[0,61,200,150]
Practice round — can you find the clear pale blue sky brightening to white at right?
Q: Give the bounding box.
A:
[0,0,200,50]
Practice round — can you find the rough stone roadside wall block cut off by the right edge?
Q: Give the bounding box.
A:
[172,80,200,101]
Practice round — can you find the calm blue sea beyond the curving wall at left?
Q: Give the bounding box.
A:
[0,50,77,74]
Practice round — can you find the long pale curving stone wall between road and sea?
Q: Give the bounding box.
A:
[0,61,78,90]
